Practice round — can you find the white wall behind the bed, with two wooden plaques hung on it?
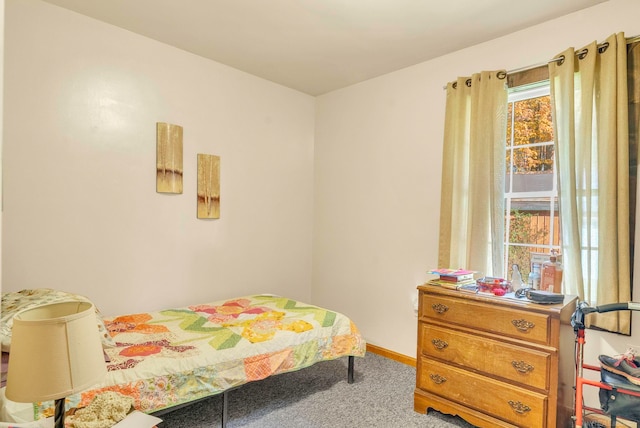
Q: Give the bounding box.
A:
[2,0,315,314]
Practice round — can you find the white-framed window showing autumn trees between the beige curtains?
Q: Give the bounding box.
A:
[504,81,561,281]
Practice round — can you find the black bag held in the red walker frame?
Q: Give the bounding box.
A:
[598,370,640,422]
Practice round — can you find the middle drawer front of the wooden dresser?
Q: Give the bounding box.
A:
[420,323,551,391]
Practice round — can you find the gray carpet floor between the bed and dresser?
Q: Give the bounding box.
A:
[158,352,472,428]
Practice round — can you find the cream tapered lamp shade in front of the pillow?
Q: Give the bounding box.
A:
[5,302,107,402]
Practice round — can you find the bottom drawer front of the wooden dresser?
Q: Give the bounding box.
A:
[418,357,548,428]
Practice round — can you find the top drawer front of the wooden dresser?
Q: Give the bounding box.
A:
[420,294,550,345]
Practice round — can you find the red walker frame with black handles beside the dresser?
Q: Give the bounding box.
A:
[571,302,640,428]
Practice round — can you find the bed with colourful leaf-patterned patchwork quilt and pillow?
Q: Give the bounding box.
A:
[0,289,366,427]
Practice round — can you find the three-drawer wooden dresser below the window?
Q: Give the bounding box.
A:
[414,285,577,428]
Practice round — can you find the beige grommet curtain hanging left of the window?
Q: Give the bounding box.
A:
[438,71,507,276]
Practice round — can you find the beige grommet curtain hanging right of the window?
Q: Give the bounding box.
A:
[549,33,631,334]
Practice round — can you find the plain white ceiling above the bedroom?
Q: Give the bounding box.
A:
[44,0,607,95]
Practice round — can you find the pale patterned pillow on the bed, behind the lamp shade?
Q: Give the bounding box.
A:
[0,288,115,352]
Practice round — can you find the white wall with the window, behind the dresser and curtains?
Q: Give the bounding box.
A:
[312,0,640,362]
